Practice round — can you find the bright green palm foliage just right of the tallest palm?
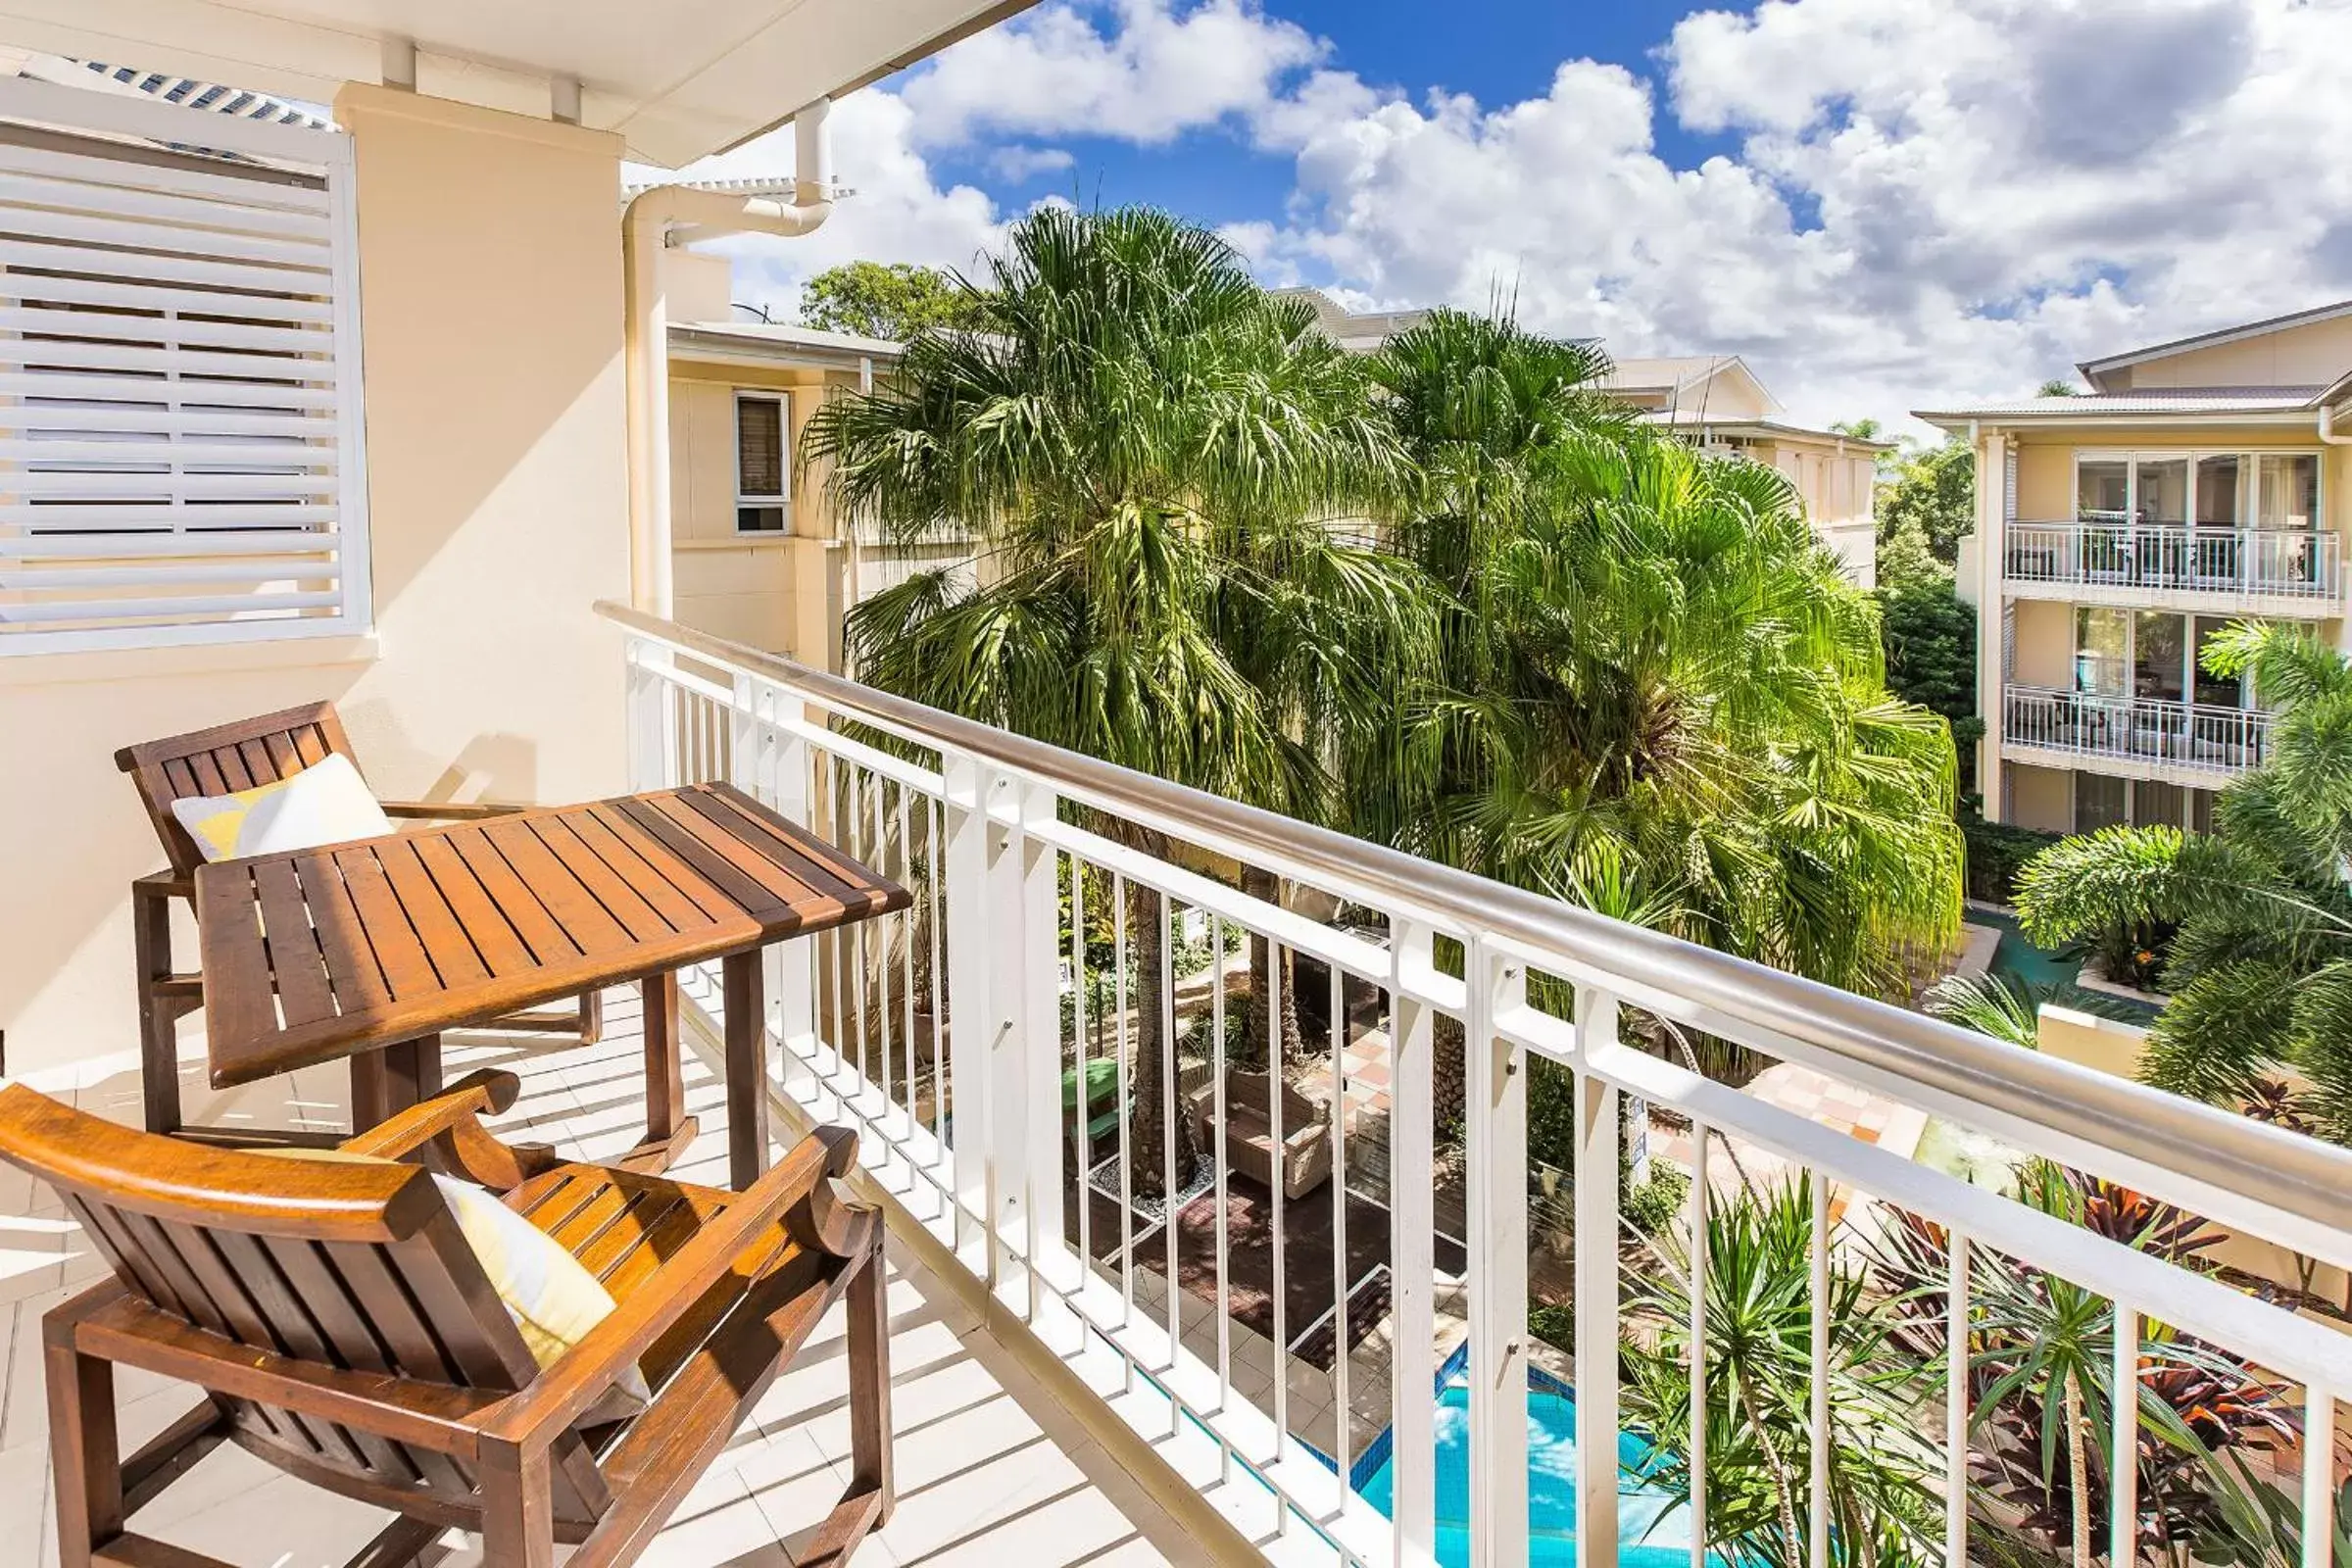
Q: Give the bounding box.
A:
[1352,311,1962,992]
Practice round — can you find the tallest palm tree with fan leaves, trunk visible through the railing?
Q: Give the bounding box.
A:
[802,207,1435,1197]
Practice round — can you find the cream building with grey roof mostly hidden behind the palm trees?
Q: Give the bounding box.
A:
[1284,289,1893,588]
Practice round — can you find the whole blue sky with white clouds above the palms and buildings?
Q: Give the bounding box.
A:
[694,0,2352,432]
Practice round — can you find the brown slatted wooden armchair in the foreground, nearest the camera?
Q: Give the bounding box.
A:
[0,1072,892,1568]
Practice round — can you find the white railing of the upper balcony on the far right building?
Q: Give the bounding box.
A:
[2001,522,2342,604]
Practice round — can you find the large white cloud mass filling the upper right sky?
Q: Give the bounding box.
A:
[1232,0,2352,429]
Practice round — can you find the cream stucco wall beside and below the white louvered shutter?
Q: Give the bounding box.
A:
[0,87,628,1072]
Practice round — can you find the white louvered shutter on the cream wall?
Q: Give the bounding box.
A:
[0,80,369,656]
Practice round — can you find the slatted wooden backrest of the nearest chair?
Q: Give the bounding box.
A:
[0,1084,610,1519]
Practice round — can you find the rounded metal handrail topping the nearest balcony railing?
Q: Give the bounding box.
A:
[595,600,2352,1260]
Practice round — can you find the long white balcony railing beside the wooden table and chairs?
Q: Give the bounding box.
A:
[600,607,2352,1568]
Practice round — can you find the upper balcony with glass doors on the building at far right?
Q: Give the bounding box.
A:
[2001,452,2345,618]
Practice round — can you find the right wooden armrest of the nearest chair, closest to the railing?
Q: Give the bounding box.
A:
[482,1128,882,1446]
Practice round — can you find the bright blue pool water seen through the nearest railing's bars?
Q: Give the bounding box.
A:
[1364,1382,1691,1568]
